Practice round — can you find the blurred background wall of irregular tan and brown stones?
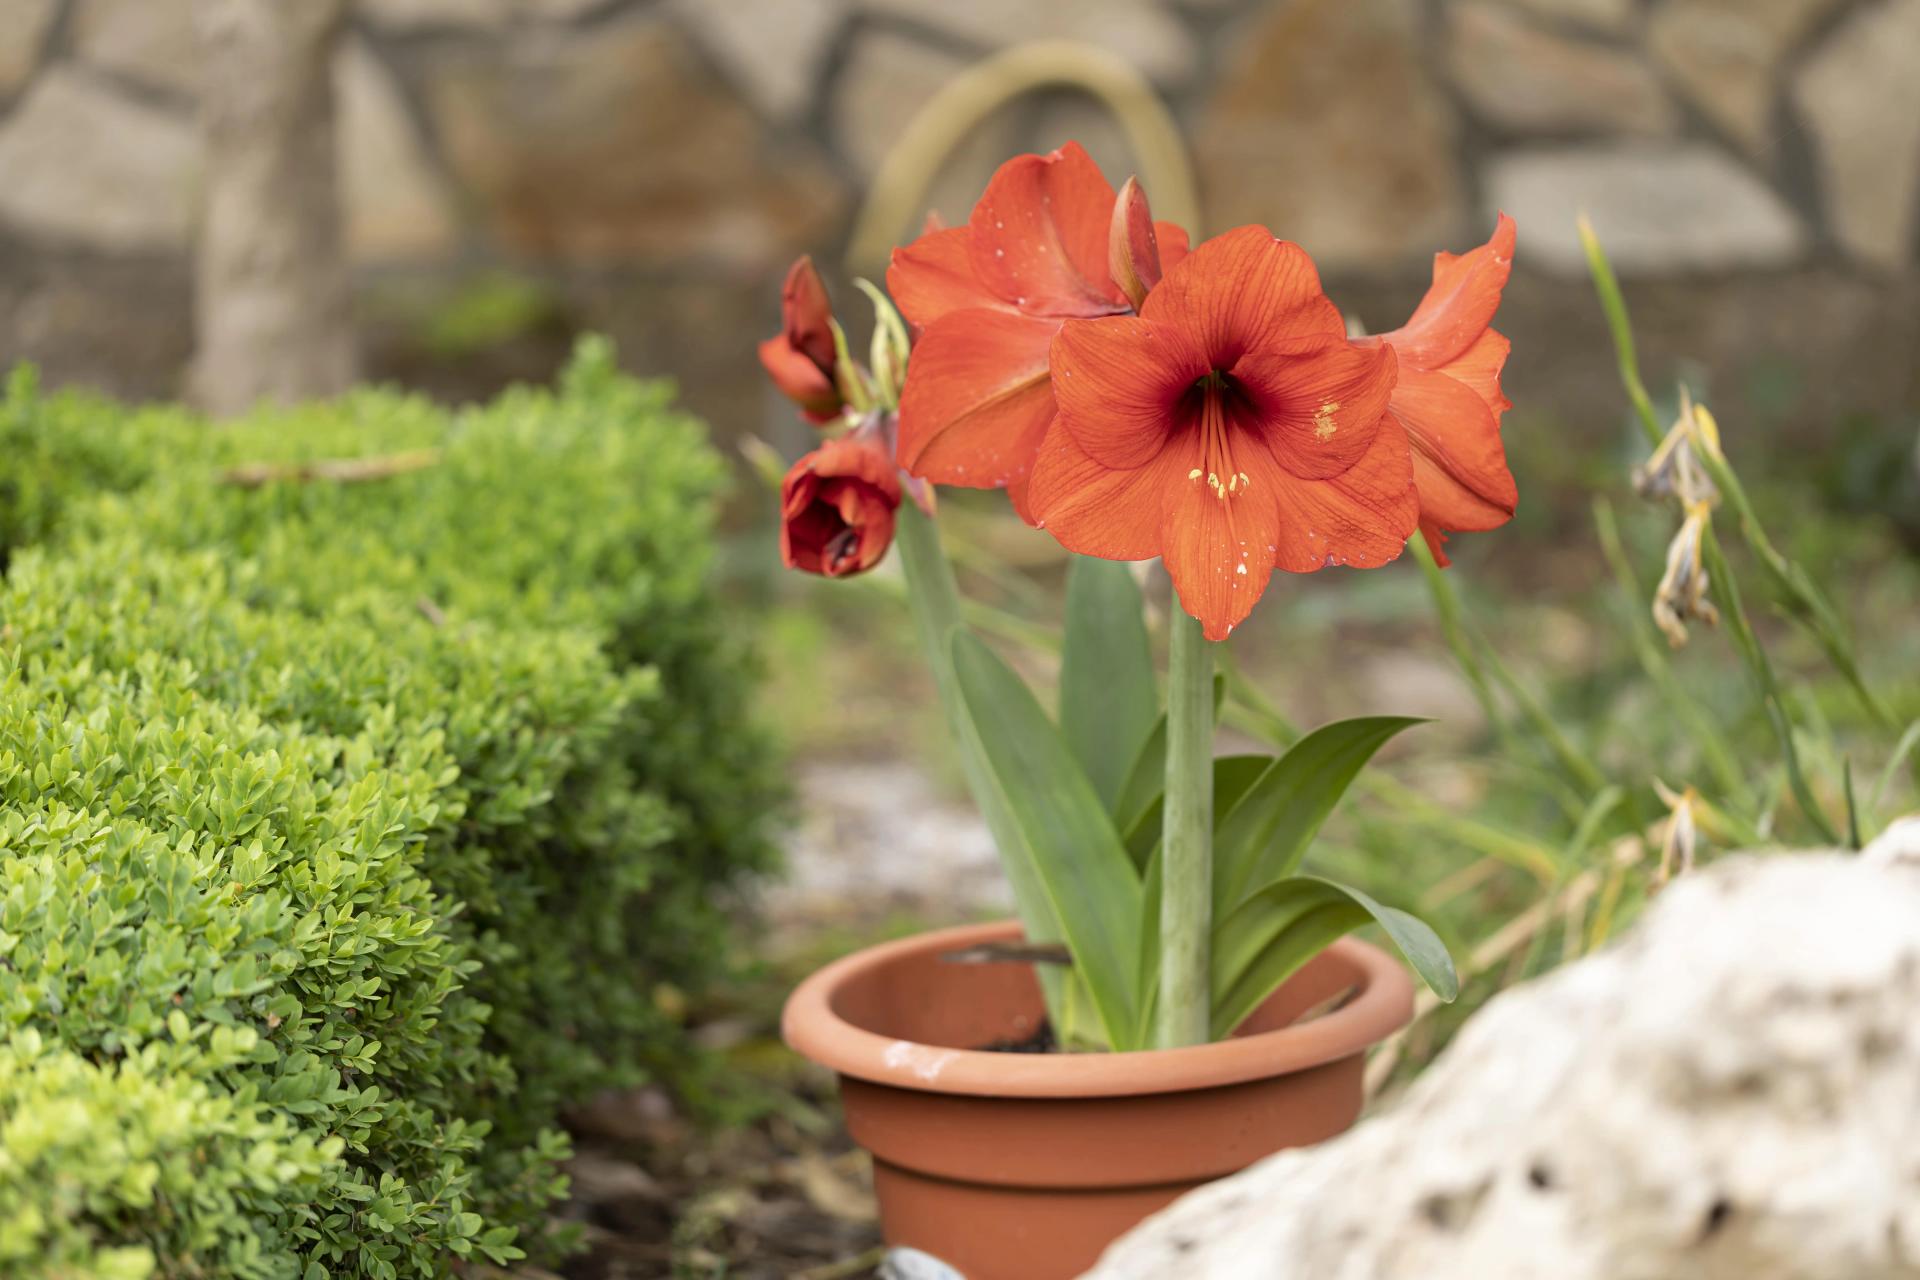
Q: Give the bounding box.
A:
[0,0,1920,445]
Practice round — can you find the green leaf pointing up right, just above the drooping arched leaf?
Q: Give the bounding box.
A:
[1213,716,1423,919]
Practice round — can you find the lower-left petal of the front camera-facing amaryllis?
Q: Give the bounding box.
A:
[1027,418,1181,560]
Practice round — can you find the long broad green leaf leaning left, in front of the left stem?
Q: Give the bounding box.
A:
[952,631,1140,1050]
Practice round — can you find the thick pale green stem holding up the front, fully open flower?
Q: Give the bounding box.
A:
[1154,599,1213,1050]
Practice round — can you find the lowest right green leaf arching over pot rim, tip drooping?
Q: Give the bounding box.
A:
[1212,875,1459,1038]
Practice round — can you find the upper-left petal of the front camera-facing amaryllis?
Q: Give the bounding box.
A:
[1052,317,1208,470]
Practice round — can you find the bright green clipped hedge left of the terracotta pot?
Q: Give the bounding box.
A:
[0,344,778,1280]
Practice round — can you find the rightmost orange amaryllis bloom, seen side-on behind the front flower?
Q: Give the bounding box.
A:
[1359,213,1519,564]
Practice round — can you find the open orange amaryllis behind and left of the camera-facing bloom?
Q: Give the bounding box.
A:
[887,142,1187,518]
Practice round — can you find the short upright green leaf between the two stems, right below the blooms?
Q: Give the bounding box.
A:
[1060,557,1160,808]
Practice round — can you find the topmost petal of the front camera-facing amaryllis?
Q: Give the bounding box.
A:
[1140,226,1346,368]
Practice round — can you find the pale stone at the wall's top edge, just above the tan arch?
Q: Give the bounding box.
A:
[862,0,1196,84]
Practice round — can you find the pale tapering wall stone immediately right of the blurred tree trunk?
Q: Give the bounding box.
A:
[334,40,459,261]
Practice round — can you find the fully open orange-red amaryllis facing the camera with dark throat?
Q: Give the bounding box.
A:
[1029,226,1419,641]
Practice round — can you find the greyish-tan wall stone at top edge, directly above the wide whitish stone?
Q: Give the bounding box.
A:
[1446,0,1678,134]
